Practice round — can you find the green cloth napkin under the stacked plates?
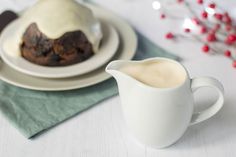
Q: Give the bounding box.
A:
[0,29,178,138]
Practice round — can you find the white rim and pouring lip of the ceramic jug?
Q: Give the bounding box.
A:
[105,57,190,91]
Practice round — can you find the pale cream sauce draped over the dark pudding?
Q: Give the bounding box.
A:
[3,0,102,56]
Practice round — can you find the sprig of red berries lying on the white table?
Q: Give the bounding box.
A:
[157,0,236,68]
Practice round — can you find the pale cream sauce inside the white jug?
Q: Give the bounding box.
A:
[120,60,186,88]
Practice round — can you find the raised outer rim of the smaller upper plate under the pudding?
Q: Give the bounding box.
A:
[0,17,120,79]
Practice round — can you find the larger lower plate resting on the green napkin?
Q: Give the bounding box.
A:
[0,5,137,91]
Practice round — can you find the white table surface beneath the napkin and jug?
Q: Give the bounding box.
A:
[0,0,236,157]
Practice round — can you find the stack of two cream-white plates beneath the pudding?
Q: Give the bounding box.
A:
[0,5,137,91]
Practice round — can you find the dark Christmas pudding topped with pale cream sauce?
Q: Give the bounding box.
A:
[3,0,102,66]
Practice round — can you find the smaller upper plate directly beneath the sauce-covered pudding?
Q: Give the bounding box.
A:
[0,15,119,78]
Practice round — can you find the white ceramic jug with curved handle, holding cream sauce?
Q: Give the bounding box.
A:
[106,58,224,148]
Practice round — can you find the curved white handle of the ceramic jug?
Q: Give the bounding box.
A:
[190,77,224,125]
